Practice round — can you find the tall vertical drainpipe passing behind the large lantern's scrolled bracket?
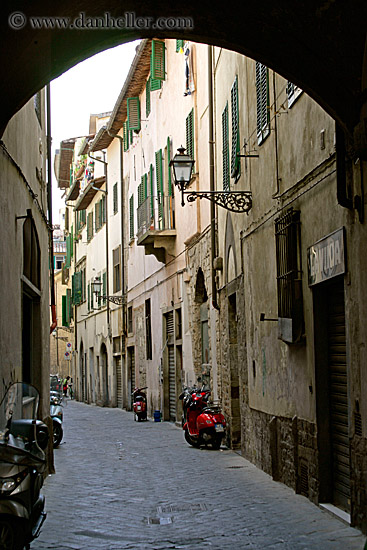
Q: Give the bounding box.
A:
[208,46,219,310]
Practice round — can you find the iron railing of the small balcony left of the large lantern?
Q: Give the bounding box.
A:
[137,195,175,236]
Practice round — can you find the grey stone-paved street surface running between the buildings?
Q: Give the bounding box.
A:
[31,401,365,550]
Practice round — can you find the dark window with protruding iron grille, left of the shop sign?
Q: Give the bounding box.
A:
[275,208,303,343]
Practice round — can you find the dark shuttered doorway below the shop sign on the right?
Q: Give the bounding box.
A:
[313,277,350,513]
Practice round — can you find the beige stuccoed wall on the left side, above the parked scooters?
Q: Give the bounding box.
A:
[0,91,50,418]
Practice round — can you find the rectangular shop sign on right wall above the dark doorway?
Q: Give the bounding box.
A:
[307,227,345,286]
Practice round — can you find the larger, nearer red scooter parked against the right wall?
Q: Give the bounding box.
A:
[179,388,226,449]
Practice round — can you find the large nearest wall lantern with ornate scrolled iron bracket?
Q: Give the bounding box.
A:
[169,146,252,214]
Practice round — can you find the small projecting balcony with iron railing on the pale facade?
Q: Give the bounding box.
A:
[137,196,176,263]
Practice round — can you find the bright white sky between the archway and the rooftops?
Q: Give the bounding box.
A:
[51,40,139,224]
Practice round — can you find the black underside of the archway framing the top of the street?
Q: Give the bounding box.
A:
[0,0,367,149]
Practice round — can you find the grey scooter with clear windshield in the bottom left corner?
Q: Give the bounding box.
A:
[0,382,49,550]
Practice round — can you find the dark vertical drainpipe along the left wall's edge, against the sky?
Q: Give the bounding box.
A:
[46,83,57,334]
